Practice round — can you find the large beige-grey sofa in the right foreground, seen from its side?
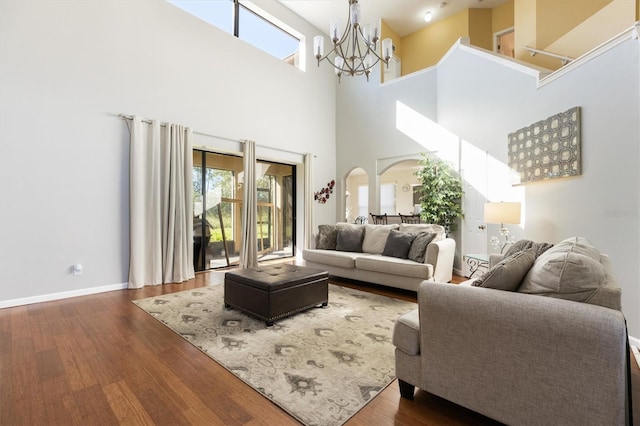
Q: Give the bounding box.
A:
[393,238,629,426]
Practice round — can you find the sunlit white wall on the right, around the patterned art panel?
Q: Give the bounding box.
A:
[337,37,640,336]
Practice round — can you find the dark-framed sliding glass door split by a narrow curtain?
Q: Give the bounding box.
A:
[193,150,295,271]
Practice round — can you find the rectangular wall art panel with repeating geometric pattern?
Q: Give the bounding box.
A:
[508,107,582,185]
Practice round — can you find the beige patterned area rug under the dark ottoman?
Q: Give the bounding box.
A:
[134,284,417,425]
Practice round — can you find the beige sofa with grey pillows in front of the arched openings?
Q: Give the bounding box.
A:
[302,223,456,291]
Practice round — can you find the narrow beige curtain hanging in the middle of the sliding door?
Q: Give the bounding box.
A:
[240,141,258,269]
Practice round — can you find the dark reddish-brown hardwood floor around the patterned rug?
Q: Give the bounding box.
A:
[0,273,640,426]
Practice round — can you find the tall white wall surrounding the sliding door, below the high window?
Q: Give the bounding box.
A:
[0,0,335,306]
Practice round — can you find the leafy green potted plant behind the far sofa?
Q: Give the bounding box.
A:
[415,153,464,234]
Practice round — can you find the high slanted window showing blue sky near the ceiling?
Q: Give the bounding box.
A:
[167,0,301,67]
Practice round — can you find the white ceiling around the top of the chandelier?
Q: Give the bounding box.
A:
[280,0,508,37]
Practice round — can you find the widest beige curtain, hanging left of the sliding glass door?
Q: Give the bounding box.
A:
[129,116,195,288]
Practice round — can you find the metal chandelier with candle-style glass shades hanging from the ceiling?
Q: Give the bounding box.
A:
[313,0,393,82]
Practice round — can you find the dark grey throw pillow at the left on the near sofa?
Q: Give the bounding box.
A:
[473,248,536,291]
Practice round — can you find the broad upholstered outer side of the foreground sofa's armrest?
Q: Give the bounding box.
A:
[418,282,627,424]
